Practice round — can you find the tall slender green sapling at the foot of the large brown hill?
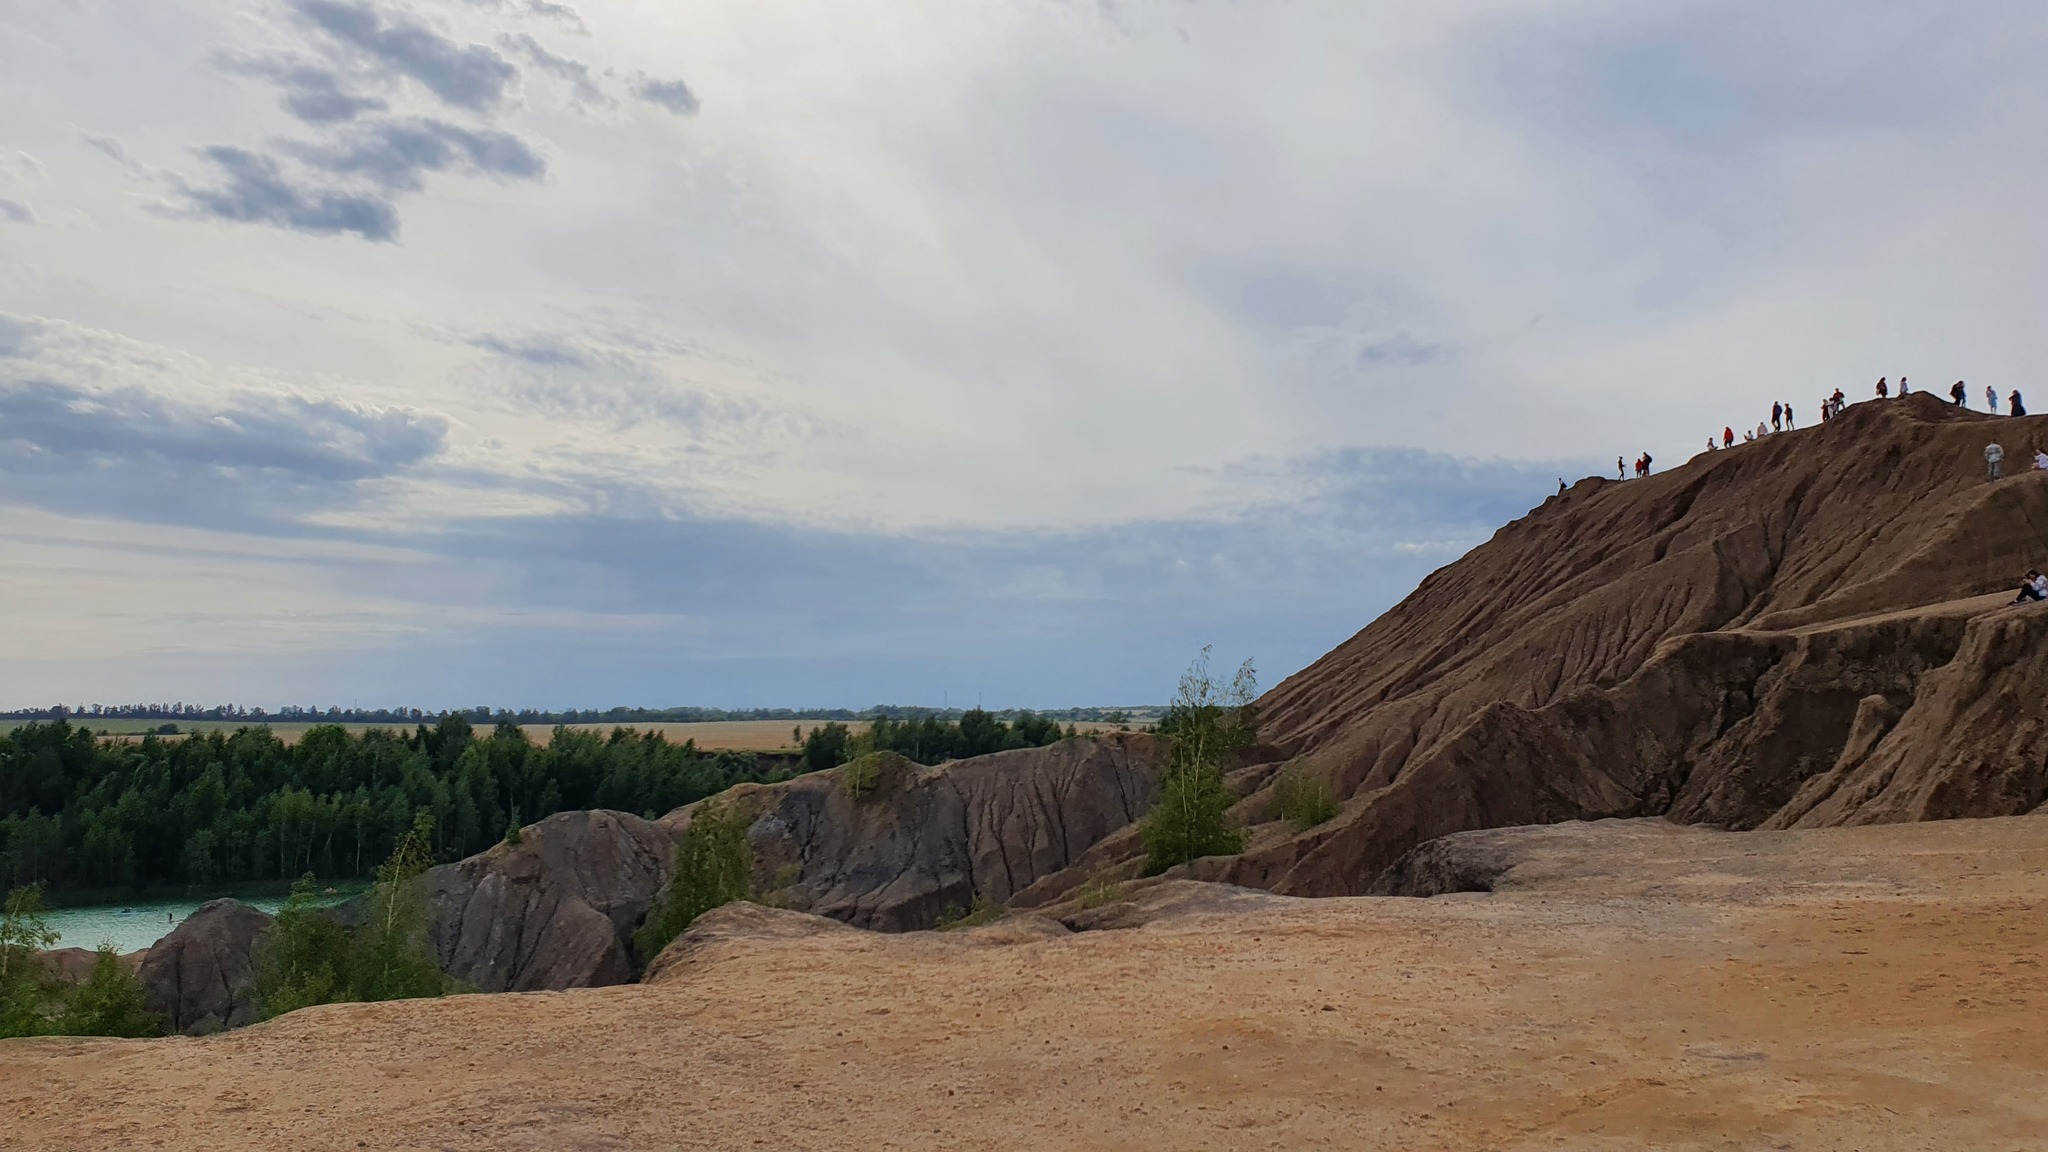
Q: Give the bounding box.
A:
[1139,648,1257,875]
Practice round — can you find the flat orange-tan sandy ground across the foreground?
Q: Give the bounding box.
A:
[0,816,2048,1150]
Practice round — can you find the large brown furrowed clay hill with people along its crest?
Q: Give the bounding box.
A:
[1190,396,2048,896]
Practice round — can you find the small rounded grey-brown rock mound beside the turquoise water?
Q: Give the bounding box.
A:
[135,900,270,1035]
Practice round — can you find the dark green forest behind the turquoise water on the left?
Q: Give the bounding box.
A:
[0,715,791,894]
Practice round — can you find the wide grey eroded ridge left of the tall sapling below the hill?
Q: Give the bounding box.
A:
[664,734,1159,931]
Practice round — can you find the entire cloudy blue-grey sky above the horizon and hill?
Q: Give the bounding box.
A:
[0,0,2048,707]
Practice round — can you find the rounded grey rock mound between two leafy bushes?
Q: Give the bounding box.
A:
[424,812,676,992]
